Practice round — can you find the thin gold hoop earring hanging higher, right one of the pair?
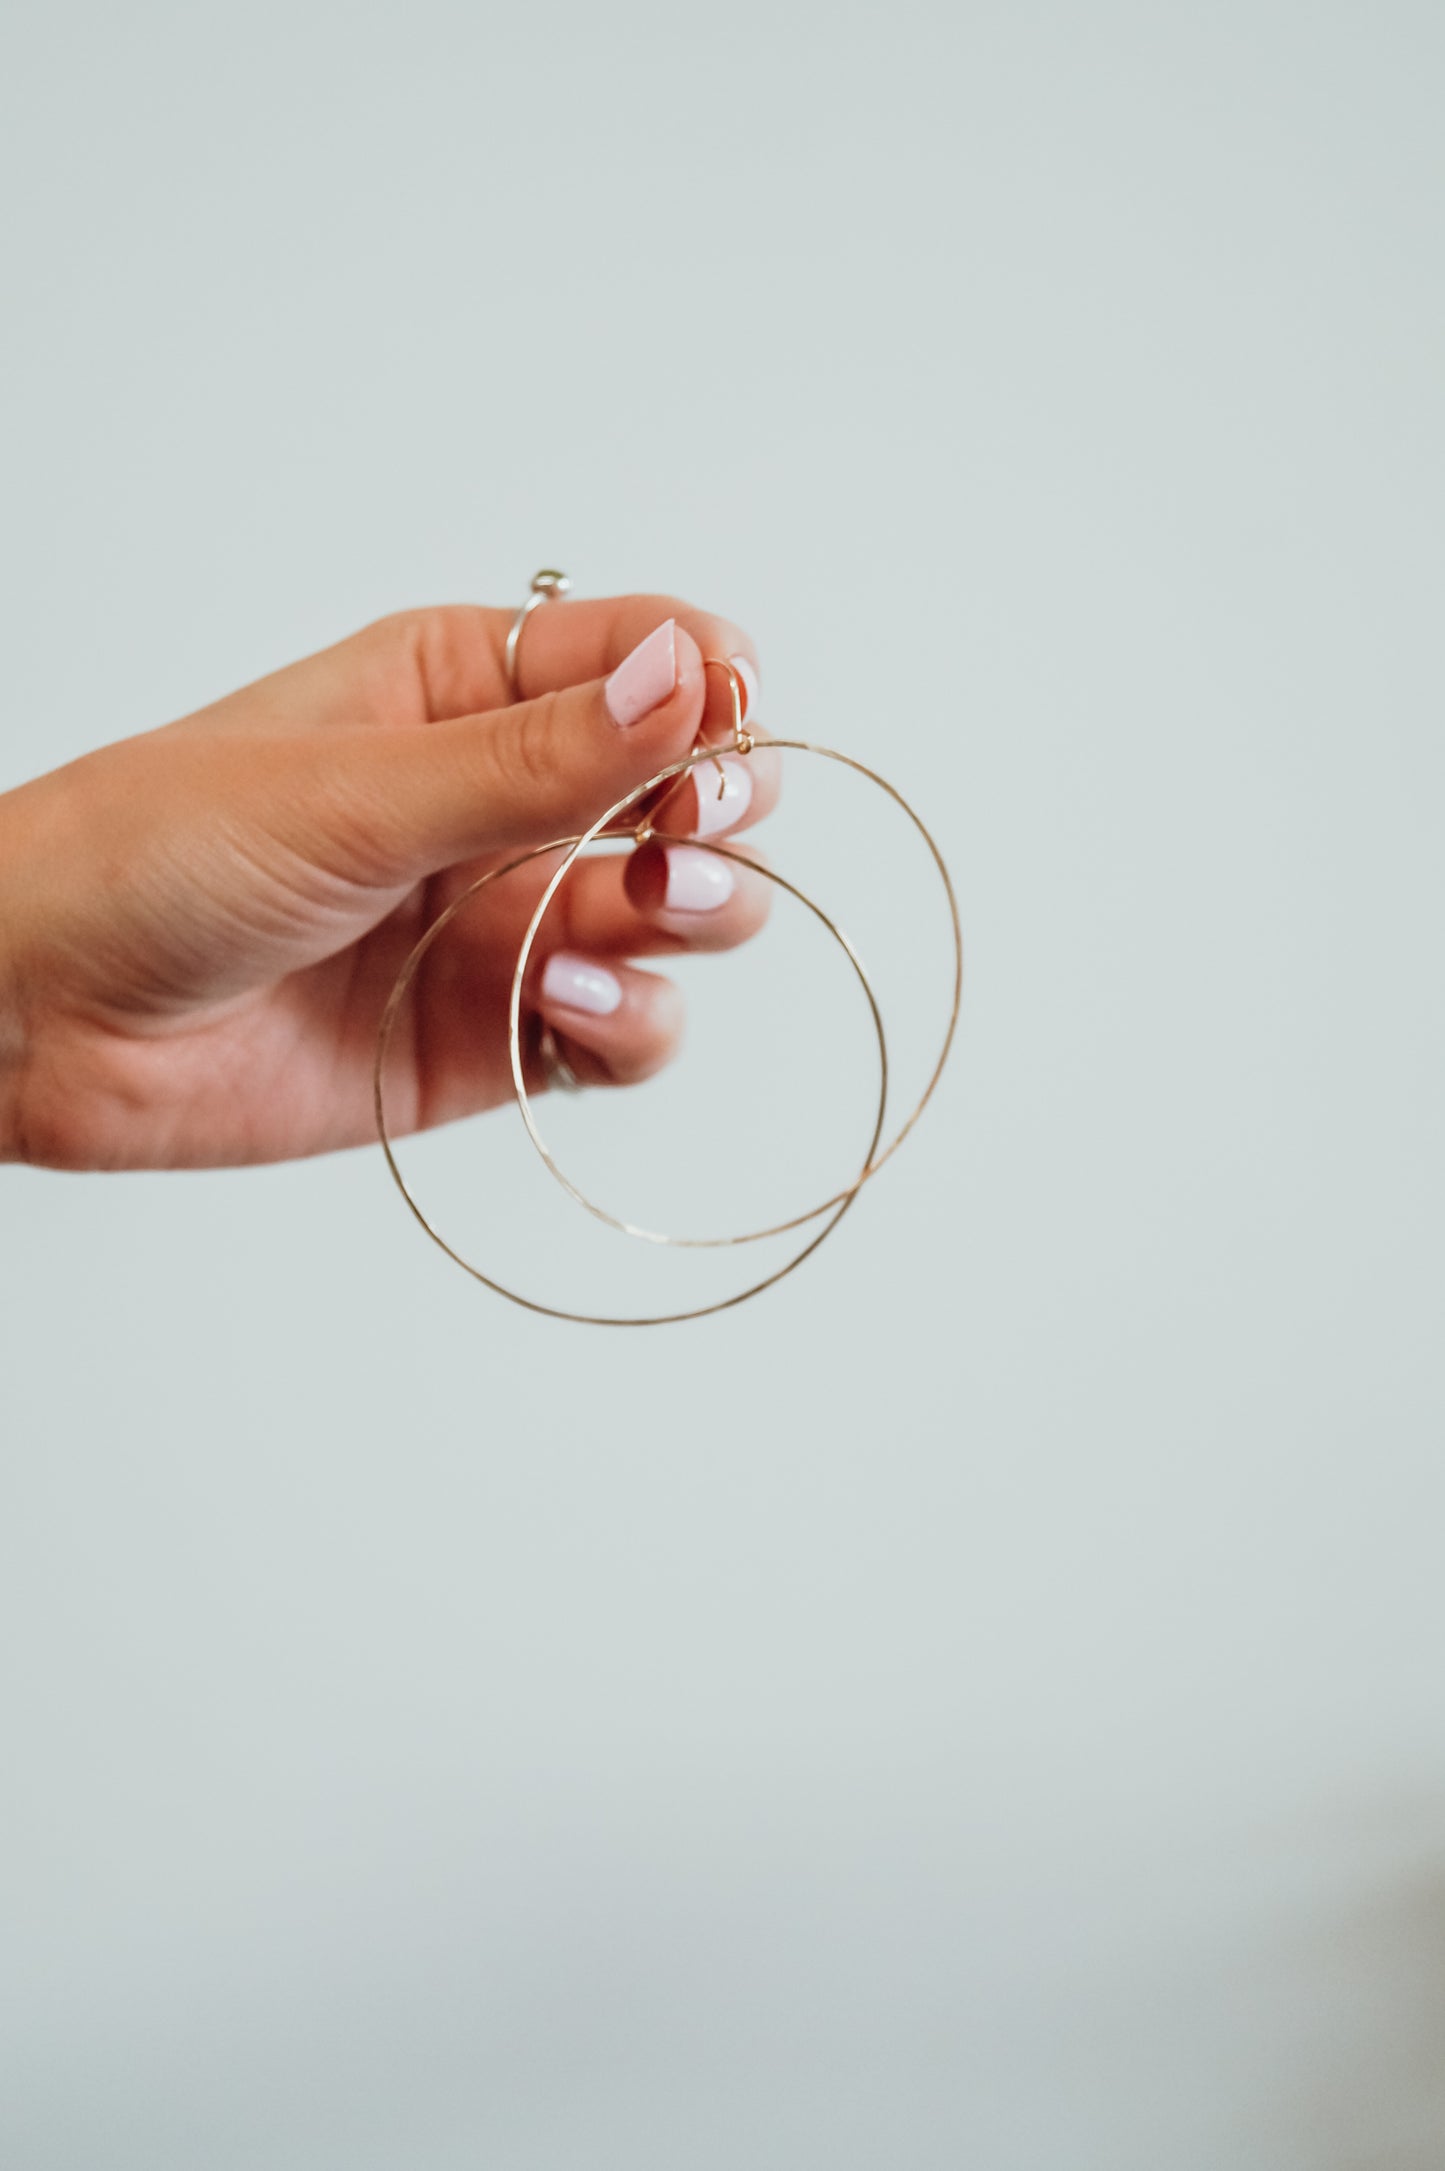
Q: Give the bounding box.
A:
[508,725,963,1250]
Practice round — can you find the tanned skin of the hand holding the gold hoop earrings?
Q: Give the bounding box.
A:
[0,595,779,1168]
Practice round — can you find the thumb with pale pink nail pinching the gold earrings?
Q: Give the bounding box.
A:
[306,619,707,884]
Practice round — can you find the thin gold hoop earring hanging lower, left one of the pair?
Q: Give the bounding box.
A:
[371,838,887,1326]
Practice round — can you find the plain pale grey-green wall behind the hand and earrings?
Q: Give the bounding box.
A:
[0,0,1445,2171]
